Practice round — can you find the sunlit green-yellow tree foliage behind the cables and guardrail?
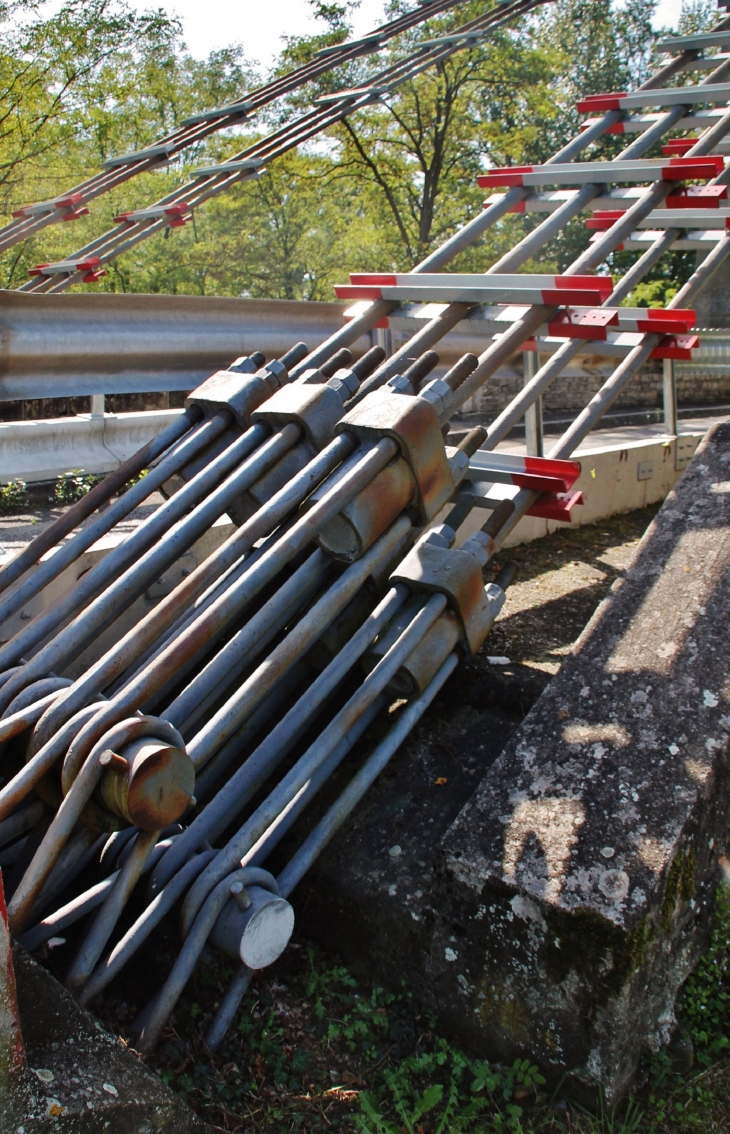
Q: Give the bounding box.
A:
[0,0,693,299]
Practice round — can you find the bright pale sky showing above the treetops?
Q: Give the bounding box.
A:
[133,0,681,67]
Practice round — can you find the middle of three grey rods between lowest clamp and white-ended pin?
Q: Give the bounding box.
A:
[181,594,447,933]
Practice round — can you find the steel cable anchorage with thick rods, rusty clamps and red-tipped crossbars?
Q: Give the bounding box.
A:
[0,11,730,1051]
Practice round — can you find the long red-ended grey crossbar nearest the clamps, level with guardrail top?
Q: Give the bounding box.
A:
[334,272,613,306]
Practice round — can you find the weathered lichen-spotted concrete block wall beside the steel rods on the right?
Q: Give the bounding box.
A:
[295,425,730,1102]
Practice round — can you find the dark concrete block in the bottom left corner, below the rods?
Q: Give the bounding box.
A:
[0,945,211,1134]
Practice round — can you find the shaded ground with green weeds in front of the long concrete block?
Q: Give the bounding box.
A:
[143,891,730,1134]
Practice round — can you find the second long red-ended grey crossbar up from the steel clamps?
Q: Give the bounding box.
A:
[477,155,724,188]
